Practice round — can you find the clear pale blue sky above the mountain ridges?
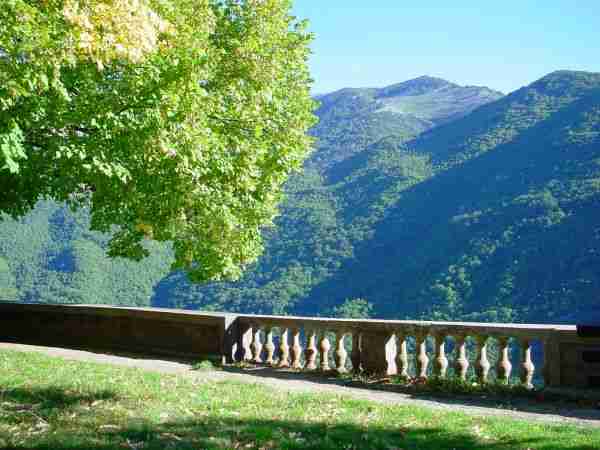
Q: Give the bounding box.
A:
[294,0,600,93]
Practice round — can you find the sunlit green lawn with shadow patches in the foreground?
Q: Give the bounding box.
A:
[0,351,600,450]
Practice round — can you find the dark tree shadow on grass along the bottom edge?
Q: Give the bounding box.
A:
[3,418,556,450]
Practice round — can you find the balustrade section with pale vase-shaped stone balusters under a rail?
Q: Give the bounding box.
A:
[232,316,574,388]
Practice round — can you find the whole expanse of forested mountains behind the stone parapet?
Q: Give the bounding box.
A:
[0,71,600,322]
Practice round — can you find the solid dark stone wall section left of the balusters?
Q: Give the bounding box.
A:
[0,302,235,359]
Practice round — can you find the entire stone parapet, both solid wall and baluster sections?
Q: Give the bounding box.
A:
[0,302,600,388]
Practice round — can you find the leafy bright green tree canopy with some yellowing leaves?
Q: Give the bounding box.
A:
[0,0,314,281]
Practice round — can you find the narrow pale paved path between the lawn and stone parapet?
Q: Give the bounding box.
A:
[0,343,600,427]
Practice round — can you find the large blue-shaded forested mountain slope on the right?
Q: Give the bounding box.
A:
[303,72,600,321]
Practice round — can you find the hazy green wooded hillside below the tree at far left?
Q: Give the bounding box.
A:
[0,201,170,306]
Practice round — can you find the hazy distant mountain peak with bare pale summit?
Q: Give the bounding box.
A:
[310,75,503,169]
